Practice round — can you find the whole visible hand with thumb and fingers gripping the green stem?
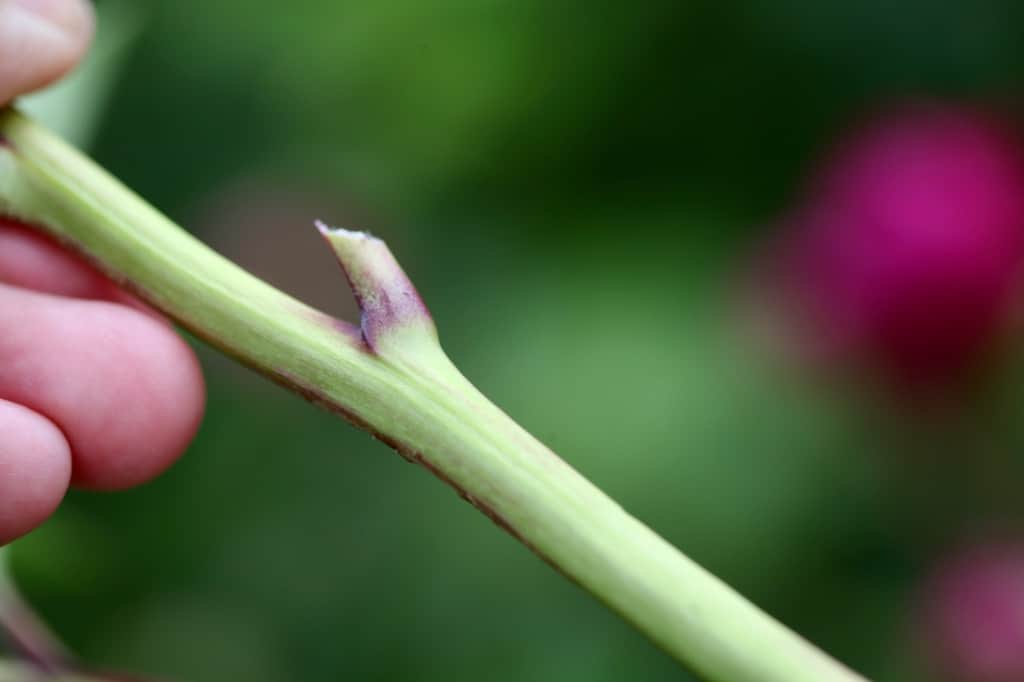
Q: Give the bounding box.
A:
[0,0,204,545]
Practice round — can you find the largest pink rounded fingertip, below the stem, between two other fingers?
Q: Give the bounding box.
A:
[0,285,205,489]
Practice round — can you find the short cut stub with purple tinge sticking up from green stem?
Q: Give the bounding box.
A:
[316,221,437,355]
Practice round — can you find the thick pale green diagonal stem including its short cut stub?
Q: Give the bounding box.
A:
[0,111,862,682]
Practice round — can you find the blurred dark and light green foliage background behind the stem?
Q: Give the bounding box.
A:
[12,0,1024,682]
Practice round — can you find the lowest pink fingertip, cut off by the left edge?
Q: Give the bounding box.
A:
[0,400,72,545]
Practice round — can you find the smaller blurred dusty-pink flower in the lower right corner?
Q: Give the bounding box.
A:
[922,544,1024,682]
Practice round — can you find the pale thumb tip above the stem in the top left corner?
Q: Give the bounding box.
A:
[0,0,93,104]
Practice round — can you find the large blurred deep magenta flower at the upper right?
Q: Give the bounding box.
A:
[776,106,1024,386]
